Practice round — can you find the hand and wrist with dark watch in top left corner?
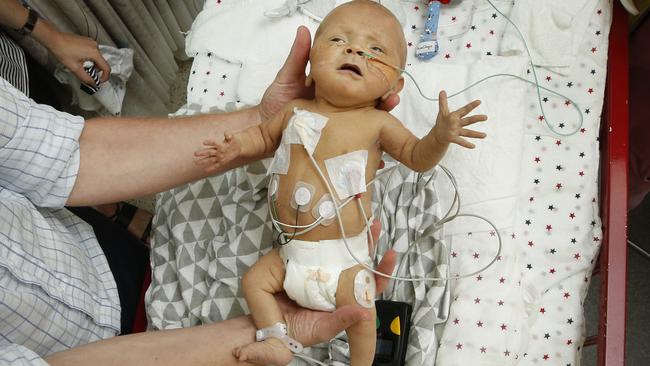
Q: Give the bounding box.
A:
[0,0,111,85]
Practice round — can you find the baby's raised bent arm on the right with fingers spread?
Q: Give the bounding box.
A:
[379,91,487,172]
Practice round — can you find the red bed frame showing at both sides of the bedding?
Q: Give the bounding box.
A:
[133,1,629,366]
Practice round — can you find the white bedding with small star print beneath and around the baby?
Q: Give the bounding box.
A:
[148,0,611,365]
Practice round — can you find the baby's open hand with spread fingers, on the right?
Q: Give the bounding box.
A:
[433,90,487,149]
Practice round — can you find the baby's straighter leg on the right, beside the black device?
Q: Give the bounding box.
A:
[336,265,377,366]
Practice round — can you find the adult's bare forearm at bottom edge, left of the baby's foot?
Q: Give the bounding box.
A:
[46,317,255,366]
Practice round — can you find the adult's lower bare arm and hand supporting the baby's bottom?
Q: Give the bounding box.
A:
[46,250,396,366]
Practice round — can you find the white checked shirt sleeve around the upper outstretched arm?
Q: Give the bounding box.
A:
[0,78,84,207]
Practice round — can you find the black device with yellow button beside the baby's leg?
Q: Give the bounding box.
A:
[372,300,412,366]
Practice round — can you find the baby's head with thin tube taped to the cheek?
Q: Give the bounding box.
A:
[310,0,406,107]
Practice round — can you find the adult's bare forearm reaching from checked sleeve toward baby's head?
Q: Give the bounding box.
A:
[67,109,259,206]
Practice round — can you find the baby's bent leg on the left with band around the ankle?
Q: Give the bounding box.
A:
[233,249,293,365]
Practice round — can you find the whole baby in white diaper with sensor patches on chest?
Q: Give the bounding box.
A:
[195,0,487,366]
